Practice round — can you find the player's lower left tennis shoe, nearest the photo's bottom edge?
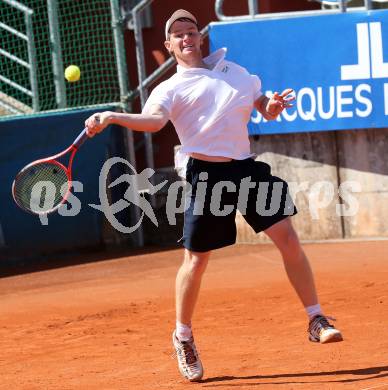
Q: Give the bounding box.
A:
[172,331,203,382]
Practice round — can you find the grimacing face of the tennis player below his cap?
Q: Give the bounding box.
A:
[164,20,202,60]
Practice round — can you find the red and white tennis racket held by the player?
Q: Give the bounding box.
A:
[12,128,88,215]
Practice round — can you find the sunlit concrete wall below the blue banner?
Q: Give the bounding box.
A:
[237,129,388,242]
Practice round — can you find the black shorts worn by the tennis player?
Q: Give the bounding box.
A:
[182,157,297,252]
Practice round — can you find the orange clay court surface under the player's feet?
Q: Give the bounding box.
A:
[0,241,388,390]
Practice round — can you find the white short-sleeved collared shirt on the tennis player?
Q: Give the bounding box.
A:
[143,48,262,176]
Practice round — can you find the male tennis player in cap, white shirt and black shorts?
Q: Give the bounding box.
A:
[85,10,342,381]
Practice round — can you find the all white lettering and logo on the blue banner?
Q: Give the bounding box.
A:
[251,22,388,128]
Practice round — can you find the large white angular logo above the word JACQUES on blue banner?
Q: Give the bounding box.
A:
[341,22,388,80]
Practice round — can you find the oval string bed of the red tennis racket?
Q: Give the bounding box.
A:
[13,162,69,213]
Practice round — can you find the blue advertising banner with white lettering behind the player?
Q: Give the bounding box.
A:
[210,10,388,134]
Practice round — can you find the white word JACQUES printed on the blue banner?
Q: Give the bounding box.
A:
[251,84,372,124]
